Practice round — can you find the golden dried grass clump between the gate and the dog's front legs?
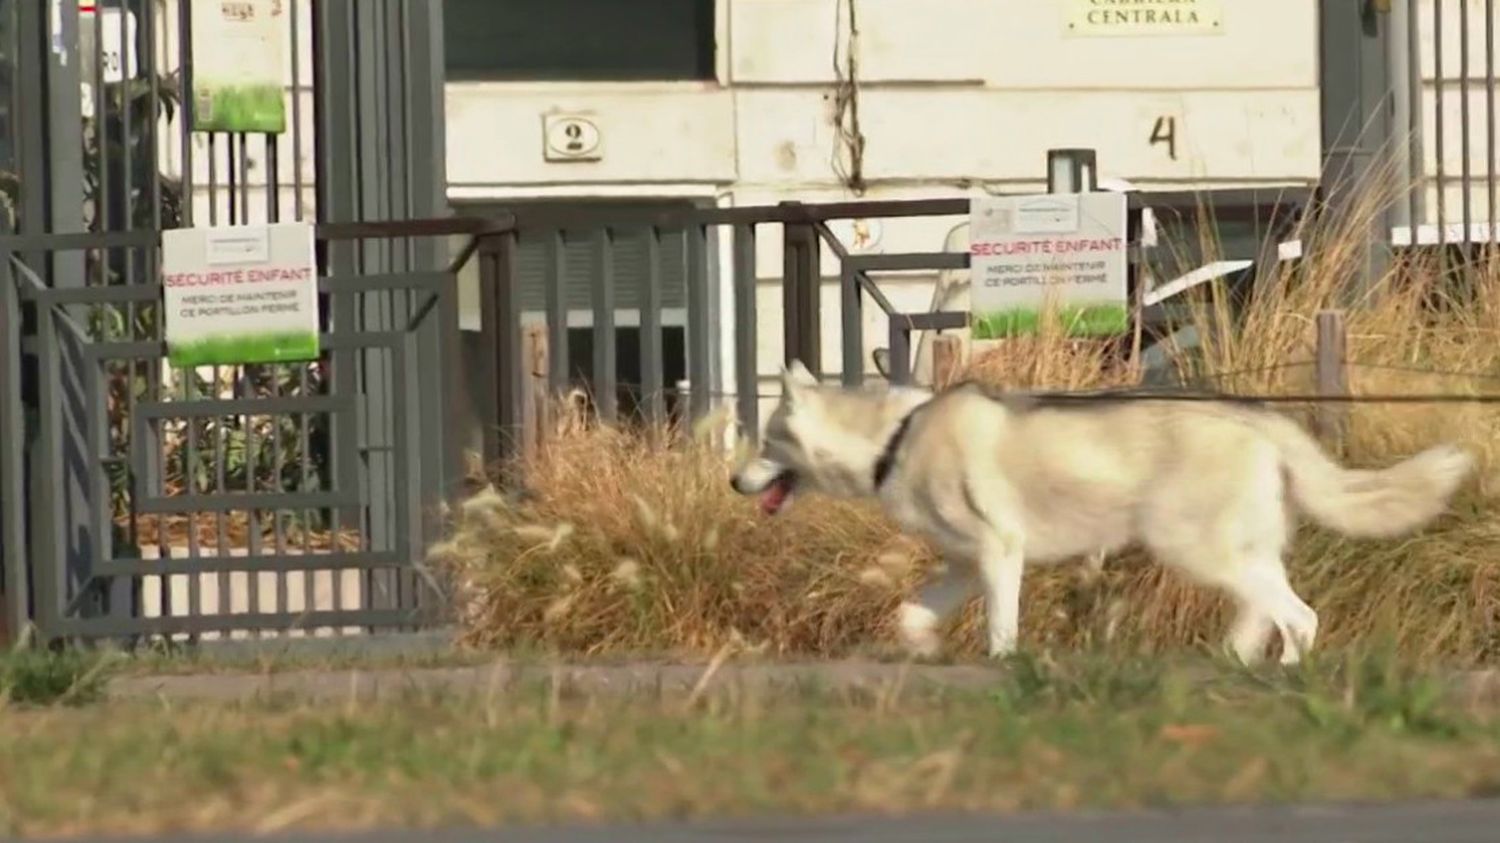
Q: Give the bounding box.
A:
[434,405,915,654]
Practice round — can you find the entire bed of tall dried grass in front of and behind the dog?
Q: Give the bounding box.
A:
[435,182,1500,665]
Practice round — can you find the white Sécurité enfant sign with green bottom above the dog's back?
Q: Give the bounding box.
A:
[969,192,1130,339]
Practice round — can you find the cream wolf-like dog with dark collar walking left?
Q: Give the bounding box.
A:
[732,363,1473,663]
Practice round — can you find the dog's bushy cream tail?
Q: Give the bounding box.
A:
[1262,416,1475,539]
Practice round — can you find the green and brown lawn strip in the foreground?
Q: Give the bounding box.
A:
[0,645,1500,836]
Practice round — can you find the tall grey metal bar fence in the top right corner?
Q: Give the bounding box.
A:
[1368,0,1500,249]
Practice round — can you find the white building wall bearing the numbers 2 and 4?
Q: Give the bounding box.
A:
[447,0,1320,408]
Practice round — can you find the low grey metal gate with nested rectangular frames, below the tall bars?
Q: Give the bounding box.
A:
[0,221,479,638]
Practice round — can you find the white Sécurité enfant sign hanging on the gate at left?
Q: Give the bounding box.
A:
[162,222,318,368]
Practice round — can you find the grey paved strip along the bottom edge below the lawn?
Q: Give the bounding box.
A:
[52,801,1500,843]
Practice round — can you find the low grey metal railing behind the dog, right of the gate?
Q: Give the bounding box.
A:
[480,189,1311,464]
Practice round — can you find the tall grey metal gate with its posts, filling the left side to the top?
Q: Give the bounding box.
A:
[0,0,456,639]
